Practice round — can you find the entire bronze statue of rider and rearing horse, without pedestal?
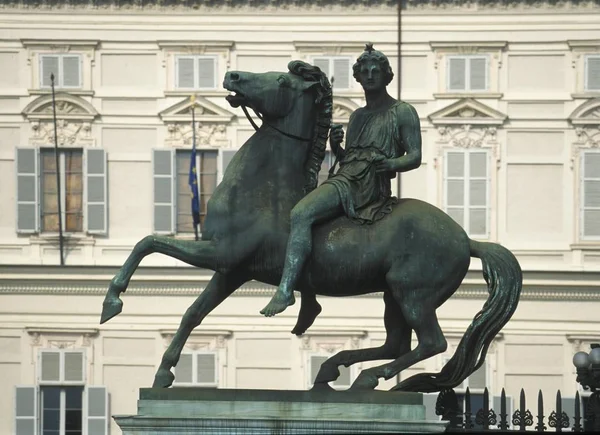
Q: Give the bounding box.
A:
[101,46,522,392]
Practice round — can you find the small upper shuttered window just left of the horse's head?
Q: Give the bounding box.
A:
[175,56,217,89]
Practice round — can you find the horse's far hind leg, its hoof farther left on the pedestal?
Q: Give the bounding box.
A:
[313,292,412,390]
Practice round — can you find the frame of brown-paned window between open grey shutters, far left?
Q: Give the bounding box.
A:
[38,147,87,235]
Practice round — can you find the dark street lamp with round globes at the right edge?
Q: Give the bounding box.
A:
[573,343,600,432]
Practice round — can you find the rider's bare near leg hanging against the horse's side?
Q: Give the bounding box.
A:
[261,184,343,316]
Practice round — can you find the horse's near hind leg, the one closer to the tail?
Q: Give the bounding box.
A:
[351,277,448,390]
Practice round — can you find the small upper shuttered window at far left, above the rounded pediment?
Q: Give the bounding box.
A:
[40,54,82,88]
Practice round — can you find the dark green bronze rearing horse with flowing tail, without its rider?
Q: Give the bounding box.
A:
[101,61,522,392]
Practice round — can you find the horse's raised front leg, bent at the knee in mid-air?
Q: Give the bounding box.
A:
[100,236,217,324]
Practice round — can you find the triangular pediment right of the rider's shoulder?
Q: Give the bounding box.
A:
[429,98,507,125]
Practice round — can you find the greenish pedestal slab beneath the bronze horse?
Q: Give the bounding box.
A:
[114,388,447,435]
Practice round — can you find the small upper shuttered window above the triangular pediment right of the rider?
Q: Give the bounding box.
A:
[447,56,488,91]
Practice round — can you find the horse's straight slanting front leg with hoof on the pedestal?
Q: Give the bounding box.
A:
[152,272,248,388]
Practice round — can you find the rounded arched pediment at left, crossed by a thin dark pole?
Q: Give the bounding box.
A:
[22,92,98,122]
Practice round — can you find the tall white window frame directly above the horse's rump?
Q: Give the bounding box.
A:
[442,148,492,240]
